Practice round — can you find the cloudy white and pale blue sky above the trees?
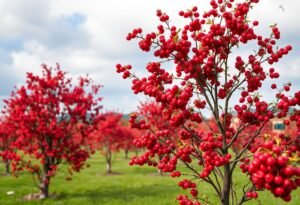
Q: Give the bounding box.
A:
[0,0,300,113]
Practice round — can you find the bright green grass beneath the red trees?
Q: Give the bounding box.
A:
[0,153,300,205]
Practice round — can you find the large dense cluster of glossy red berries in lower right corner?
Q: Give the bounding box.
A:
[240,141,300,201]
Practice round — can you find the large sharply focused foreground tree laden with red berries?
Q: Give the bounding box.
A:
[116,0,300,205]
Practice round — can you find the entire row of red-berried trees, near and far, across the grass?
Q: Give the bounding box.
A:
[0,0,300,205]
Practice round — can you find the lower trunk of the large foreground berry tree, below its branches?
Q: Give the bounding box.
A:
[221,164,232,205]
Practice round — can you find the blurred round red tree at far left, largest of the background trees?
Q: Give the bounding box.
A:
[4,65,101,198]
